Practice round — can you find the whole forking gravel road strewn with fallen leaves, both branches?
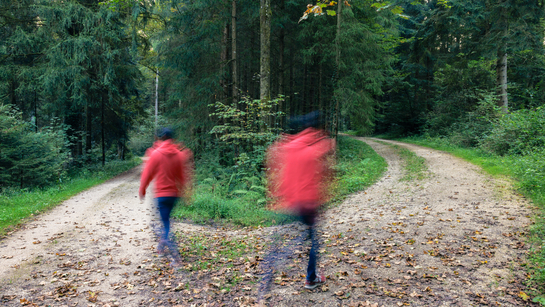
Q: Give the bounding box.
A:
[0,138,532,306]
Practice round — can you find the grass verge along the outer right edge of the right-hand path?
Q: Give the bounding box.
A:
[398,138,545,305]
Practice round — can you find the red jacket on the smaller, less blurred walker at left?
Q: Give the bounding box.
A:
[139,140,193,197]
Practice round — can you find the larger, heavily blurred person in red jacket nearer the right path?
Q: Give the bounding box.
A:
[267,112,335,289]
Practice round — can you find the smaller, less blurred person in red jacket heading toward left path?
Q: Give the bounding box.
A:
[138,128,193,253]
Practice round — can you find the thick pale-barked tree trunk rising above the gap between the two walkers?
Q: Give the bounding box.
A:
[259,0,272,101]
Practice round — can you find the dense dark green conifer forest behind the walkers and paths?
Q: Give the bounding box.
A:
[0,0,545,188]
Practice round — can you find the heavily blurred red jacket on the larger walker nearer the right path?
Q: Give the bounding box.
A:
[267,128,335,211]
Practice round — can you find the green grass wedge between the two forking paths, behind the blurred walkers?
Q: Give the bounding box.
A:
[173,136,387,226]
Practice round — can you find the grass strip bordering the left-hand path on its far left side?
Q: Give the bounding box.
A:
[0,159,140,237]
